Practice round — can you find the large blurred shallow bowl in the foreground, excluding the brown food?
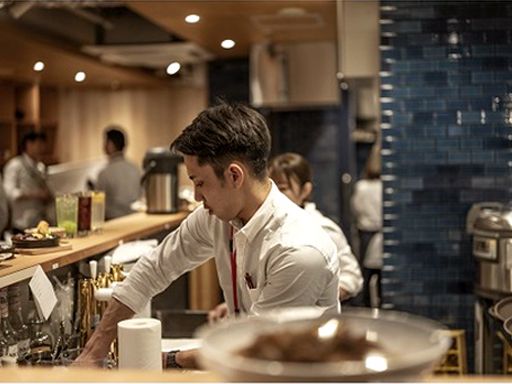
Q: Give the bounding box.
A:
[198,309,451,382]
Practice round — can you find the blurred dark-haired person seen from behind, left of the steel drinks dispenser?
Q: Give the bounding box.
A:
[95,125,141,220]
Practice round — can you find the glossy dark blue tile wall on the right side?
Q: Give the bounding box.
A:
[380,0,512,372]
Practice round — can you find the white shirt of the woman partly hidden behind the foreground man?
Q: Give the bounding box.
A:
[304,203,363,296]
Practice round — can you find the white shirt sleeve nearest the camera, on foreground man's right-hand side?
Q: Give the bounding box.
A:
[251,246,338,314]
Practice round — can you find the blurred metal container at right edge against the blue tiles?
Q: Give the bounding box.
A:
[473,206,512,293]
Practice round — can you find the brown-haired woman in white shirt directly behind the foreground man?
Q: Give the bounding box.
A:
[269,153,363,301]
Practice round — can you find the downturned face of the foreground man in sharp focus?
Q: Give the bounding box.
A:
[183,155,238,221]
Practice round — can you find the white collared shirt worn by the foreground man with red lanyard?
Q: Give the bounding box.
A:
[113,182,340,314]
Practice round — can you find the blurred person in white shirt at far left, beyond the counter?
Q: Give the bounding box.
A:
[4,132,54,232]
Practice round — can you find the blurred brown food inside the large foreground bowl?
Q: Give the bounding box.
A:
[239,324,383,363]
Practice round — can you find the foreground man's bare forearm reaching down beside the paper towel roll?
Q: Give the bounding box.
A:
[76,299,135,365]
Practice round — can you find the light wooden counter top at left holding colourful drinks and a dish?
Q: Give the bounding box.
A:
[0,212,188,288]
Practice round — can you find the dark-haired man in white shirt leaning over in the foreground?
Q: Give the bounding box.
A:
[79,104,340,368]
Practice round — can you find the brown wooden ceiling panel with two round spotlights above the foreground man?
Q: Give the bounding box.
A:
[127,0,336,57]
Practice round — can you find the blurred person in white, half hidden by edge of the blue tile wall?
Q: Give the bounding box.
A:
[351,145,383,307]
